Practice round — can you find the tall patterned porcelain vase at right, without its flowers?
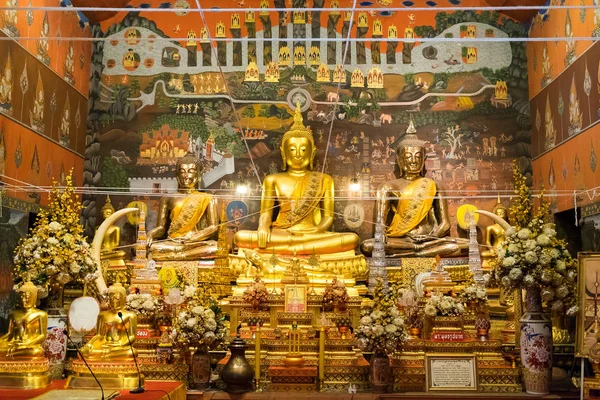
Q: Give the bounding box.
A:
[520,288,552,395]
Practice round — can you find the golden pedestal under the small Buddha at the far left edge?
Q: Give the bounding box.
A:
[0,358,50,389]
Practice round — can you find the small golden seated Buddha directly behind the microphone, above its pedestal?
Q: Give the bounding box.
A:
[81,283,137,361]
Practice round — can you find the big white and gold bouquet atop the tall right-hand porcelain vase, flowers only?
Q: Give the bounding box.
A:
[496,162,578,315]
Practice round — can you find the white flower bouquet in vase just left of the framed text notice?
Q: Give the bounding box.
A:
[356,279,407,393]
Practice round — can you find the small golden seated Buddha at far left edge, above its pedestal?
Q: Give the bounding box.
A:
[0,282,48,358]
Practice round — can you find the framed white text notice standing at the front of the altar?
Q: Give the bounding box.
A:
[425,353,477,391]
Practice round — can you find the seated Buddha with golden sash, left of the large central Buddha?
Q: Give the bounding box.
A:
[147,153,218,261]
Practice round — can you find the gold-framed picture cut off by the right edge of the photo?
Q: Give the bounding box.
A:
[575,252,600,358]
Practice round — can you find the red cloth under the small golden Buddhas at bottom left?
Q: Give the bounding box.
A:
[0,380,185,400]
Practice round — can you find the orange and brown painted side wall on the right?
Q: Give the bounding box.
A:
[527,1,600,215]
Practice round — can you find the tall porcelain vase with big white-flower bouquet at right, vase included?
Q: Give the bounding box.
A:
[496,166,577,395]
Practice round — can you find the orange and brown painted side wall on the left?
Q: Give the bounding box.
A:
[0,0,91,332]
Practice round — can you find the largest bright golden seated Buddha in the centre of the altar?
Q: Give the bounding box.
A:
[234,107,358,255]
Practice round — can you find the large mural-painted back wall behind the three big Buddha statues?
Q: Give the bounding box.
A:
[85,0,531,244]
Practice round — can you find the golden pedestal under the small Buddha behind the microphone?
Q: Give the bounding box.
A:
[66,359,144,390]
